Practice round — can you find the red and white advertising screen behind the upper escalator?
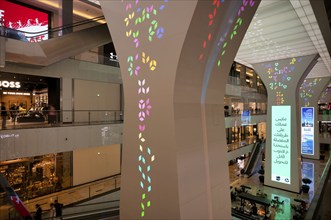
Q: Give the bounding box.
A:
[0,0,48,42]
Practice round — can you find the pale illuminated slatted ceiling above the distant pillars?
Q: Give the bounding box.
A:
[235,0,331,78]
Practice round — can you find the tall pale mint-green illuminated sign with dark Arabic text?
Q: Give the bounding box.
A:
[271,105,291,184]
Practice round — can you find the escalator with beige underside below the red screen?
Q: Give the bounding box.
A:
[1,16,111,66]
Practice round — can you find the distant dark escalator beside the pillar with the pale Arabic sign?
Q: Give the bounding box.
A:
[244,141,265,177]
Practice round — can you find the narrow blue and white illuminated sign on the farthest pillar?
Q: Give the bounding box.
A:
[301,107,314,155]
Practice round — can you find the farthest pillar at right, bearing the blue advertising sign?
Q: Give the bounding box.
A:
[299,77,330,160]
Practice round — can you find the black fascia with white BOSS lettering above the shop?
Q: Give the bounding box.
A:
[0,72,50,92]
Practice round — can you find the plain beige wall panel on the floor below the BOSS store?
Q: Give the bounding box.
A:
[73,144,121,186]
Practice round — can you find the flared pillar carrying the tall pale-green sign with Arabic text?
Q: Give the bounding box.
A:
[253,55,318,193]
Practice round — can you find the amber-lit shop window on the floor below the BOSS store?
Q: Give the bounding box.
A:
[0,152,72,200]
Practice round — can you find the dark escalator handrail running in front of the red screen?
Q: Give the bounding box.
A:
[1,15,105,37]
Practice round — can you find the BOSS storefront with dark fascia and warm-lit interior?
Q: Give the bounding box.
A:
[0,72,60,123]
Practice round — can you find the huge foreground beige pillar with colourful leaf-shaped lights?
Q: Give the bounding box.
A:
[100,0,259,219]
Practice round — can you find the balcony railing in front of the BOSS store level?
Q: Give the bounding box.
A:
[2,110,123,129]
